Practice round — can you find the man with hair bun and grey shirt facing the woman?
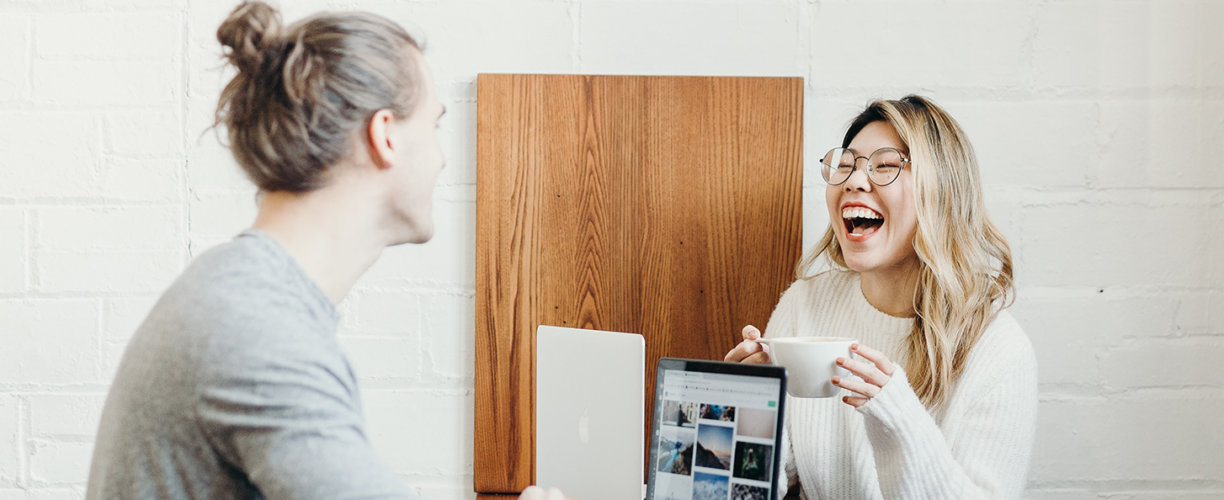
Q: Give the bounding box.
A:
[86,1,562,500]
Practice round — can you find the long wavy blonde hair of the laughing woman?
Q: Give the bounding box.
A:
[796,96,1015,408]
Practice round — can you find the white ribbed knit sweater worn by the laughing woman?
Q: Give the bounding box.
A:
[765,271,1037,499]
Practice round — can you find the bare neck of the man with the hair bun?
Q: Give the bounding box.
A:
[252,186,388,304]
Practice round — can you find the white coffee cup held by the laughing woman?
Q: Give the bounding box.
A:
[756,337,858,397]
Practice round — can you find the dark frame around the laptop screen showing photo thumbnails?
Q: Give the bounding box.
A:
[645,358,787,500]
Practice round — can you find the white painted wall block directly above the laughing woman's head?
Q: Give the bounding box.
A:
[810,1,1033,90]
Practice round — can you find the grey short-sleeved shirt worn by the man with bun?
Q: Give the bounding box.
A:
[86,230,415,499]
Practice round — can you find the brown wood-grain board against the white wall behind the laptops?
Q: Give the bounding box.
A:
[474,75,803,493]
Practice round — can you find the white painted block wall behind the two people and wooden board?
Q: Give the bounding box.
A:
[0,0,1224,500]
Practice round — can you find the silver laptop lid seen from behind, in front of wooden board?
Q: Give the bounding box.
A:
[536,325,646,500]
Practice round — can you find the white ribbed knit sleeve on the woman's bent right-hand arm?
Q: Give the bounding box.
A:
[859,322,1037,499]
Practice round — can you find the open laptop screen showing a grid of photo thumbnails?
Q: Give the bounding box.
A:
[646,358,786,500]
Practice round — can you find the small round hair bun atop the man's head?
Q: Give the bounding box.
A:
[217,1,282,74]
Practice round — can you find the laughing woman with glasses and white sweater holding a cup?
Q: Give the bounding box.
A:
[726,96,1037,499]
